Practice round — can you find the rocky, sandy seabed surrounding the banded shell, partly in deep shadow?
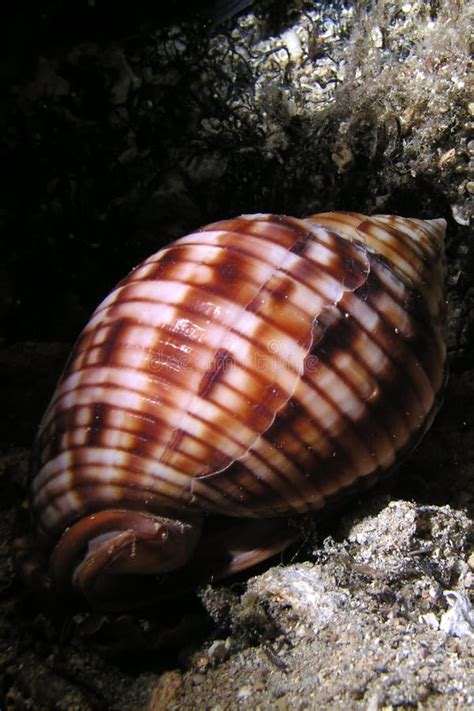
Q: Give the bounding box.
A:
[0,0,474,711]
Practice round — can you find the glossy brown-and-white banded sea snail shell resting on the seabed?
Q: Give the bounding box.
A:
[24,212,446,604]
